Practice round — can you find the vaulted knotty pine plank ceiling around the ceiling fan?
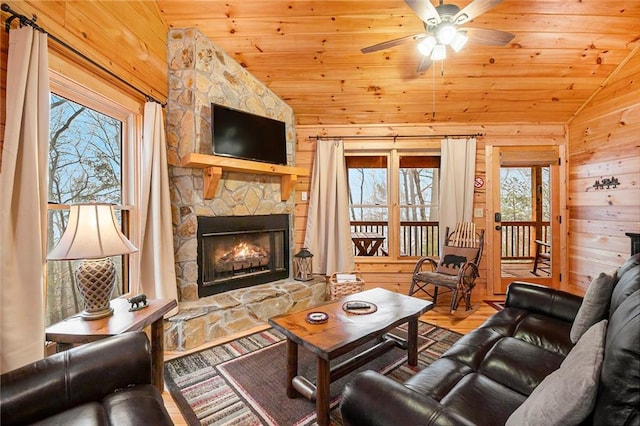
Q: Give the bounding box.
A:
[156,0,640,125]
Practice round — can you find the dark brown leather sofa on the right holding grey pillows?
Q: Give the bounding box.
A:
[340,254,640,426]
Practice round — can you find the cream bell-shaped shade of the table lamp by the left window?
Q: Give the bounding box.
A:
[47,203,138,260]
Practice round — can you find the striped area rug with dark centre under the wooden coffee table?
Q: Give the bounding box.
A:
[165,322,461,426]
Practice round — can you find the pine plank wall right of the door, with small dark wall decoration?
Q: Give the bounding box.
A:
[568,48,640,288]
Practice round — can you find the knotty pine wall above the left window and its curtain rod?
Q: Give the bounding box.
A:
[0,0,168,168]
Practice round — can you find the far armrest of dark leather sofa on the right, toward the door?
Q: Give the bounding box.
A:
[505,281,582,322]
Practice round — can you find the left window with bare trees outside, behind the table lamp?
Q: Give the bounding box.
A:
[45,75,136,325]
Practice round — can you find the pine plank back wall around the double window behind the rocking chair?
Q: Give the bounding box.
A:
[295,123,566,299]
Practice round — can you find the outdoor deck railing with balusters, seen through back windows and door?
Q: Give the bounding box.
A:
[351,221,551,260]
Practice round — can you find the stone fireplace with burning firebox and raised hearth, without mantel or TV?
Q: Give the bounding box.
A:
[165,28,326,350]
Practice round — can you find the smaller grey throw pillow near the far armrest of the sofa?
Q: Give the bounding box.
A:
[570,272,614,343]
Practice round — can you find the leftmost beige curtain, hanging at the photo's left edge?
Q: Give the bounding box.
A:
[0,27,49,372]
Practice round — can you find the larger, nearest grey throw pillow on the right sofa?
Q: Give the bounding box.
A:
[506,320,607,426]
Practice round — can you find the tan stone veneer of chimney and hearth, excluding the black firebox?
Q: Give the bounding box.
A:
[166,28,311,348]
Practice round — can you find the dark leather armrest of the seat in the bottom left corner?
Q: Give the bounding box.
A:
[0,331,151,424]
